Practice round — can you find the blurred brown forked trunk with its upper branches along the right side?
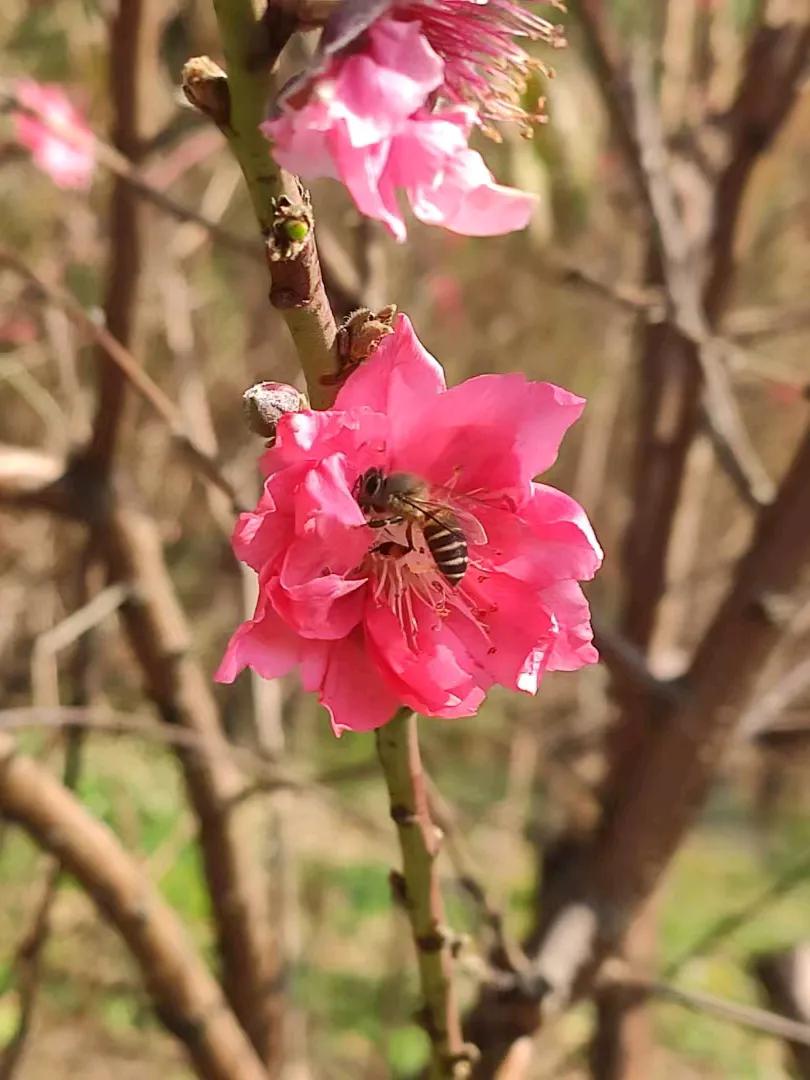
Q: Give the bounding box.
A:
[469,10,810,1078]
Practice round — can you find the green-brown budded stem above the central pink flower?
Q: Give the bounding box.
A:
[214,0,337,408]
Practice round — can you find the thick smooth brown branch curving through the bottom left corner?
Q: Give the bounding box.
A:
[0,735,267,1080]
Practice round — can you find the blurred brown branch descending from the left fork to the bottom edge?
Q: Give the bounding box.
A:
[94,510,282,1063]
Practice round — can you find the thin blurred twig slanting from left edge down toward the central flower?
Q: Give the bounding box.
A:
[0,246,241,512]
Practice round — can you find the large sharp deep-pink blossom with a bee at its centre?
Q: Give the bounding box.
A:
[217,315,602,734]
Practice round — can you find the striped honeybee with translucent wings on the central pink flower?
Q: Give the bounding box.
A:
[354,469,487,585]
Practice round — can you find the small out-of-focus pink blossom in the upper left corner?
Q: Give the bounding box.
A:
[14,79,95,189]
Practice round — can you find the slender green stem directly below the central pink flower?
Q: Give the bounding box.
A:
[377,708,470,1080]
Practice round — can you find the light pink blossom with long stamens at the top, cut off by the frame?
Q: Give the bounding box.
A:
[262,0,559,241]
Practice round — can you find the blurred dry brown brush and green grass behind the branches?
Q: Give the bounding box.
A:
[0,0,810,1080]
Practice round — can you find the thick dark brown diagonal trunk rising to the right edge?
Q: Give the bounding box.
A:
[527,421,810,1019]
